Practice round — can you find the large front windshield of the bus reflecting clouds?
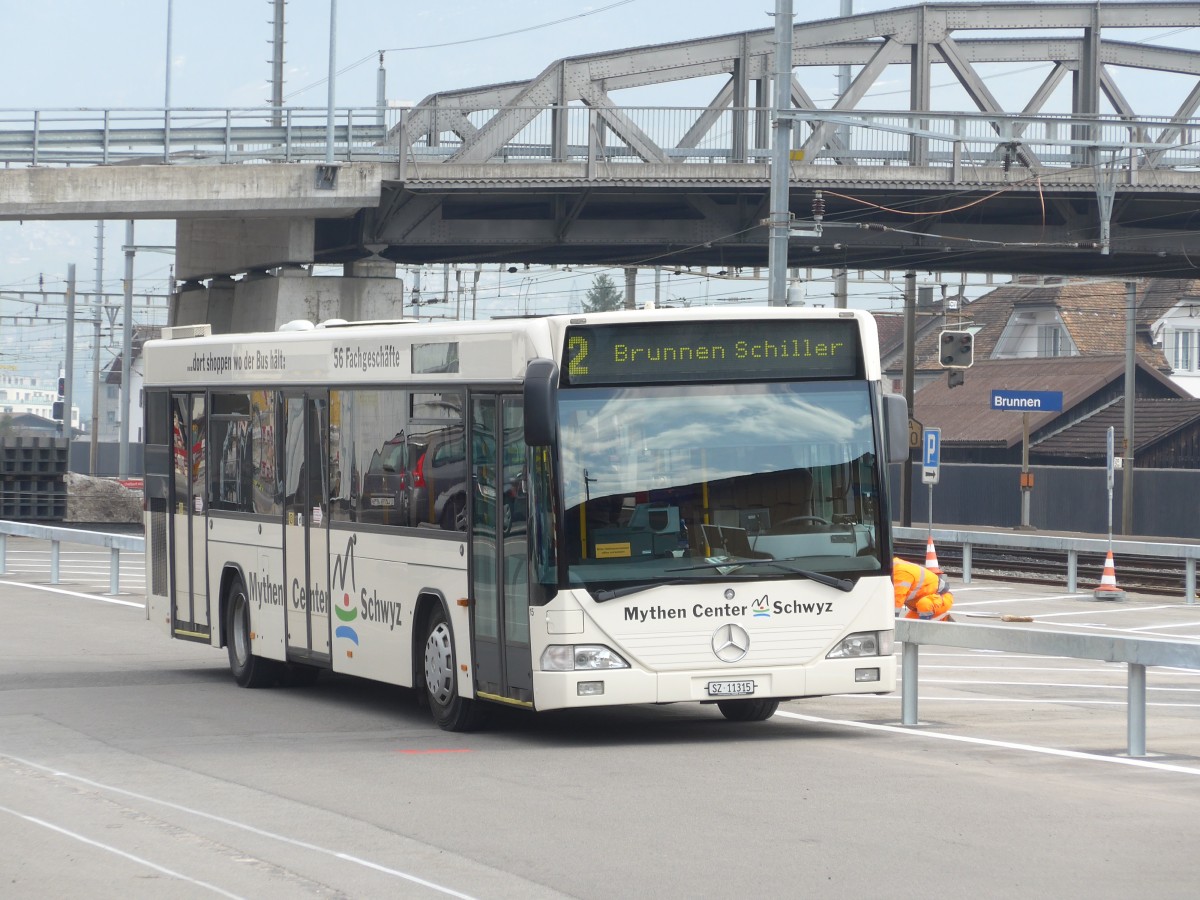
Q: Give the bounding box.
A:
[559,382,881,590]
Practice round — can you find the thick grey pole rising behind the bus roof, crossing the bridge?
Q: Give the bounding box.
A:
[767,0,792,306]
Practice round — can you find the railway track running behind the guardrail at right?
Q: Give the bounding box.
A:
[895,540,1187,596]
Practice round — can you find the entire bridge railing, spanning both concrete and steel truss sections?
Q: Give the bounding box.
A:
[0,106,1200,176]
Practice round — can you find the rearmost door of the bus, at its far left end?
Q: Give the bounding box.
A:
[170,394,211,641]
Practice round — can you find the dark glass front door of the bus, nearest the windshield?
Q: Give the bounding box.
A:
[468,395,533,707]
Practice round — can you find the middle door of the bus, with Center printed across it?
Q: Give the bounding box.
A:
[282,392,330,665]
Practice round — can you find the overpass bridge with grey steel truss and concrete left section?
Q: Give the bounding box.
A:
[0,2,1200,326]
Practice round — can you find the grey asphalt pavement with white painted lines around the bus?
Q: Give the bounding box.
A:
[0,540,1200,900]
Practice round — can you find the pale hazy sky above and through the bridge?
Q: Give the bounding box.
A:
[0,0,1200,396]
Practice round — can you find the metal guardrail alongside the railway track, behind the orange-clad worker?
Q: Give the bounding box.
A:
[892,527,1200,605]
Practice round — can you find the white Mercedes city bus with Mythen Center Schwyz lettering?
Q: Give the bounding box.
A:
[144,307,907,730]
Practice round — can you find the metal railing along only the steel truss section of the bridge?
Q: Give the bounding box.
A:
[397,107,1200,180]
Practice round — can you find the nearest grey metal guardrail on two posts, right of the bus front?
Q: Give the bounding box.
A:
[895,619,1200,756]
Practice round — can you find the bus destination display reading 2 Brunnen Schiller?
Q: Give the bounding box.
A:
[562,319,859,385]
